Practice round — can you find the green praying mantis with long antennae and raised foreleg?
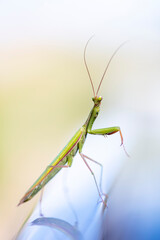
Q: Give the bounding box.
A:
[18,37,128,206]
